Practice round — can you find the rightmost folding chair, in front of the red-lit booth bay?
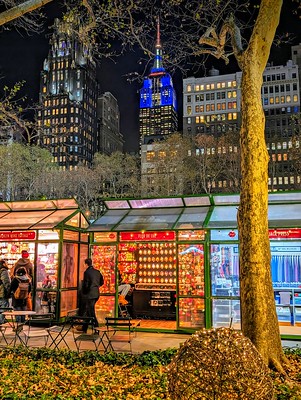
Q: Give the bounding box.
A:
[100,317,141,352]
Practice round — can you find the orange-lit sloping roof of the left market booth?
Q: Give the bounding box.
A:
[0,199,87,230]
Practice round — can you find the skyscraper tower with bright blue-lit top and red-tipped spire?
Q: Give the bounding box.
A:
[139,19,178,144]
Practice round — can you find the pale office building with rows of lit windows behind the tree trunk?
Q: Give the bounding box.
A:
[183,45,301,191]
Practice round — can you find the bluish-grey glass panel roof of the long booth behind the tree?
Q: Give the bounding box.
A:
[88,192,301,232]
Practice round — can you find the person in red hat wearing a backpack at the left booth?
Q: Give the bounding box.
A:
[11,267,31,322]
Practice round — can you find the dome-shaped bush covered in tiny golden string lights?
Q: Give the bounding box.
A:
[168,328,274,400]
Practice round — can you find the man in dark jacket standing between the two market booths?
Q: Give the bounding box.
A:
[81,258,104,331]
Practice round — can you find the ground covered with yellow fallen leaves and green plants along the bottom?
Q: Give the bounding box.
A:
[0,348,301,400]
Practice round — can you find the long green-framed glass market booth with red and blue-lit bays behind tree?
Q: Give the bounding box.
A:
[88,192,301,335]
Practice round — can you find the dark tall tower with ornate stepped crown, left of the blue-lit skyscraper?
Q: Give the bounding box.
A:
[38,19,98,170]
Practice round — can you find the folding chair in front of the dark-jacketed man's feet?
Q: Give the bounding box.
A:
[69,315,102,352]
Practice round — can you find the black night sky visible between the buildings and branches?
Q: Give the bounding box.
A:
[0,1,301,152]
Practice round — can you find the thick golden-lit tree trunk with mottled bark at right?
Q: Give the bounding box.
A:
[238,0,285,370]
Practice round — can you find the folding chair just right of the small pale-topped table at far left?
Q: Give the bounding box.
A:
[22,313,54,347]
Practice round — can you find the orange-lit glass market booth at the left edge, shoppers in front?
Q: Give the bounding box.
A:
[0,199,89,320]
